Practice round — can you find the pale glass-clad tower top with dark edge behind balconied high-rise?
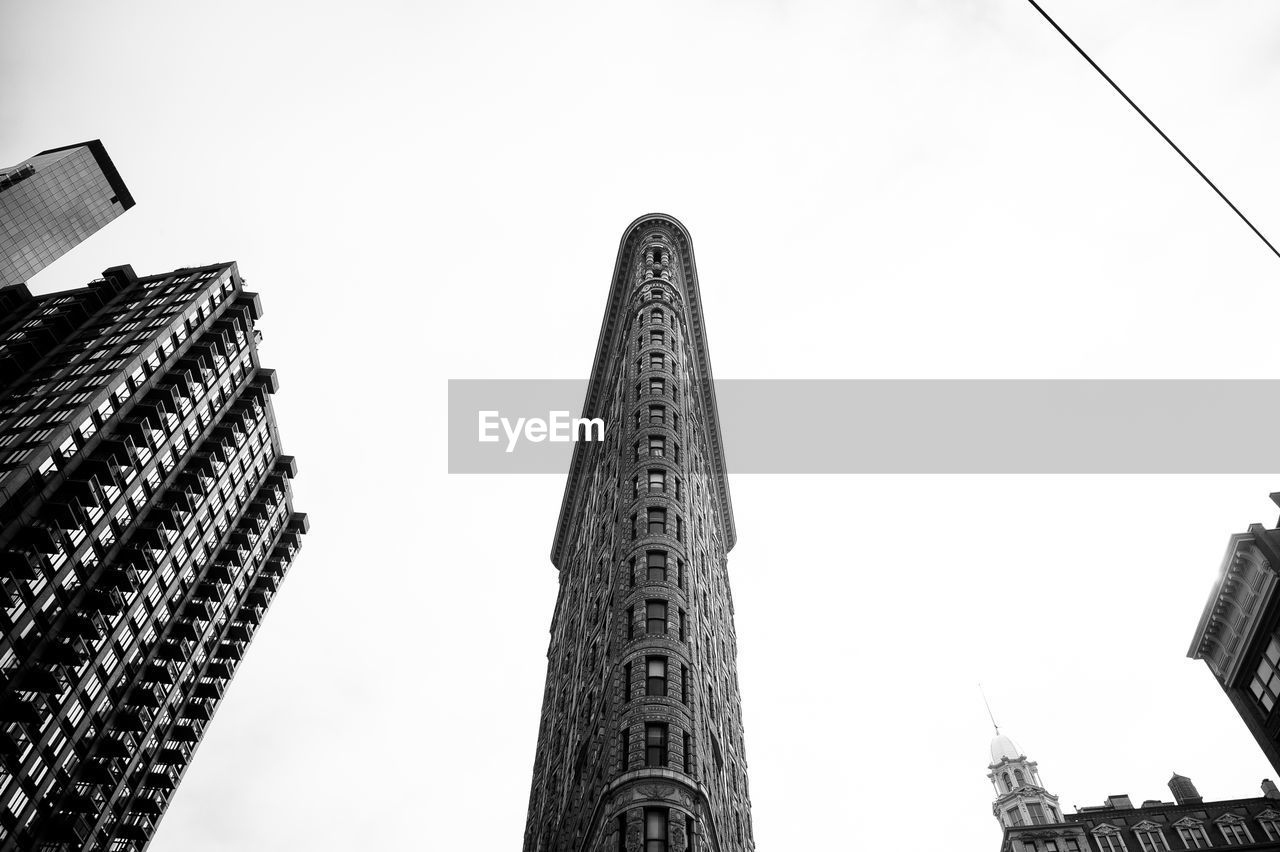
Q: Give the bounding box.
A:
[0,139,133,287]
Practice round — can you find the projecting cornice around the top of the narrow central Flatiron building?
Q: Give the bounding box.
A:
[552,214,737,568]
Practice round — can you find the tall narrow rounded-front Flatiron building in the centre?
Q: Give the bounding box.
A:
[524,214,755,852]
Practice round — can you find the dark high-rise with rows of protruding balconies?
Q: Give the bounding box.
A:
[0,264,307,852]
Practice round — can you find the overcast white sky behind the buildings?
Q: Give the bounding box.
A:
[0,0,1280,852]
